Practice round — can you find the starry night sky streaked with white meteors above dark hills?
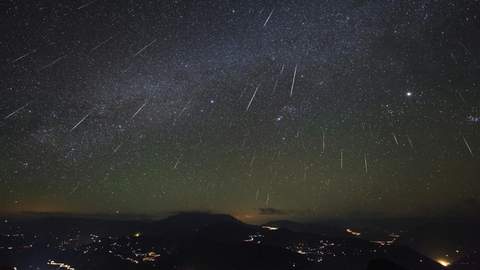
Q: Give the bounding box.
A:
[0,0,480,223]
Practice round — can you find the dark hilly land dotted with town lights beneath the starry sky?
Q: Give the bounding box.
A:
[0,213,479,270]
